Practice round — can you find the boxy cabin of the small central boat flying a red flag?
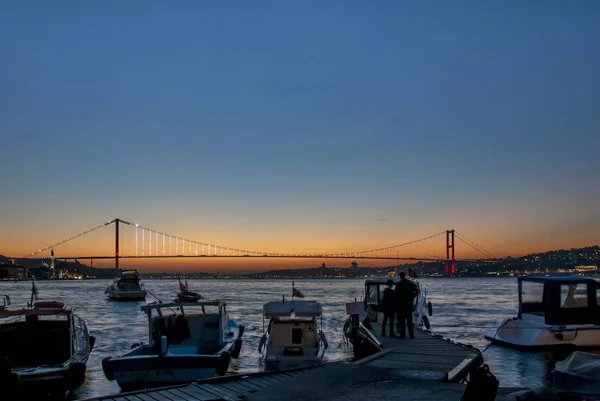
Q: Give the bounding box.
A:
[263,300,323,356]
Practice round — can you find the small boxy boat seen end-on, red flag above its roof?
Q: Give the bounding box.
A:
[258,300,327,370]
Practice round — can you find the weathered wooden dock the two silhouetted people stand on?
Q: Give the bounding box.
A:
[87,324,483,401]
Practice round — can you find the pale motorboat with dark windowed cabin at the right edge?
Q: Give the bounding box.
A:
[485,276,600,350]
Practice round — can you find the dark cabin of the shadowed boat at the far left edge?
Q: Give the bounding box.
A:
[0,302,88,368]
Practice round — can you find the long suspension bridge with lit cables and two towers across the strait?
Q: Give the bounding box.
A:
[15,218,499,275]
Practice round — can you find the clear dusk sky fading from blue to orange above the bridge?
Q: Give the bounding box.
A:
[0,0,600,269]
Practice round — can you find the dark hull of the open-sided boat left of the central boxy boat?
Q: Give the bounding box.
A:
[102,352,231,389]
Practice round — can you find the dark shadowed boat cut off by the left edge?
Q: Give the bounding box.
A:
[0,290,95,398]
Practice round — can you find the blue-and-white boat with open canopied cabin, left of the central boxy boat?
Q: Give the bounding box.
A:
[102,300,244,389]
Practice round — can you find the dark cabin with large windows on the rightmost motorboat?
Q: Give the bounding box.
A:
[518,276,600,325]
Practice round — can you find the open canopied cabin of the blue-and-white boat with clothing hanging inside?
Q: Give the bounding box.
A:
[141,301,234,354]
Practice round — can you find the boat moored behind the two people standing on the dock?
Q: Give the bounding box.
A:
[344,271,433,355]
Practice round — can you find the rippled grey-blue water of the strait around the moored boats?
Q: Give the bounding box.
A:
[0,277,565,398]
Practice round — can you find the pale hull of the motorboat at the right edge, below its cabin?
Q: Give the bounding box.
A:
[484,316,600,350]
